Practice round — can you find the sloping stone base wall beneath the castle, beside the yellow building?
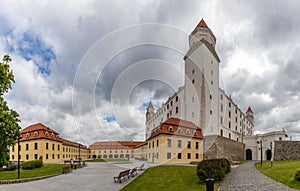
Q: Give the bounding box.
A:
[203,135,245,161]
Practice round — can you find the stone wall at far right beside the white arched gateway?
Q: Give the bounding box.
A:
[274,141,300,160]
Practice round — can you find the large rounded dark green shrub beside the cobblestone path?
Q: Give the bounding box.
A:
[197,159,230,183]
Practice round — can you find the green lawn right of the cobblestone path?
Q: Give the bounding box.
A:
[255,160,300,190]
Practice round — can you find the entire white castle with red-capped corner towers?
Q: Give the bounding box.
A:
[146,19,254,142]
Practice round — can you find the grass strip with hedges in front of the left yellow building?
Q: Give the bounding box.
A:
[0,164,63,180]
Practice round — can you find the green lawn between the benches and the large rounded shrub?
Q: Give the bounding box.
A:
[121,166,218,191]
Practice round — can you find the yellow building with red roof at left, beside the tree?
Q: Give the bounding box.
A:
[10,123,90,163]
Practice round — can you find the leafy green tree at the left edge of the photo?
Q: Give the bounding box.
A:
[0,55,21,167]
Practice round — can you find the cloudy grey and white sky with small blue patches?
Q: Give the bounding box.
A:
[0,0,300,145]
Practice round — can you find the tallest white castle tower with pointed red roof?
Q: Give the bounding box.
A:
[184,19,220,136]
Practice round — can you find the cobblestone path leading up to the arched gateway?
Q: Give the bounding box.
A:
[219,161,295,191]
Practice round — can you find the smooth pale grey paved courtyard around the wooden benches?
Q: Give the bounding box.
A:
[0,161,148,191]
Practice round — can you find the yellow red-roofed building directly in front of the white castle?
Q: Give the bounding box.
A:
[147,118,203,163]
